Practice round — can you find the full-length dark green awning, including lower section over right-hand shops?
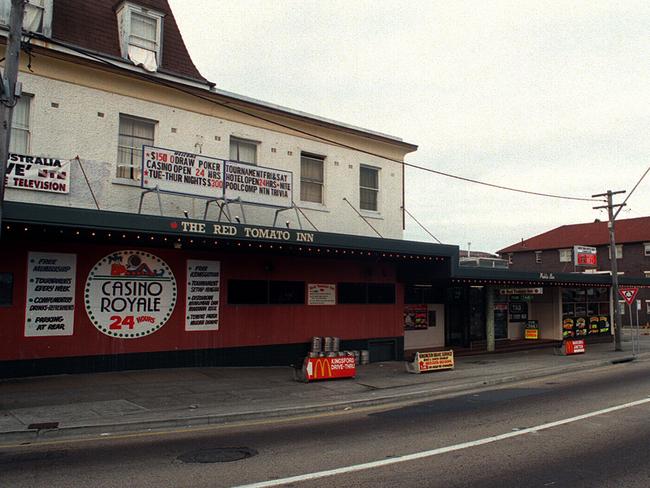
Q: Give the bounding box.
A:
[2,201,650,288]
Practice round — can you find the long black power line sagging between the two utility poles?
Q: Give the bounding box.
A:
[31,34,601,202]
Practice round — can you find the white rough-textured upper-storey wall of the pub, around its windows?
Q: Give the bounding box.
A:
[7,72,402,238]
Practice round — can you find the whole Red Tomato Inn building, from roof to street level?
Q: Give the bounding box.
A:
[0,0,650,377]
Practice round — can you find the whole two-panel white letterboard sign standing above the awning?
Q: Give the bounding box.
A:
[141,146,293,207]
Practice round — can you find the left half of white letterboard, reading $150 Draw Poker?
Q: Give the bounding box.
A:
[142,146,224,198]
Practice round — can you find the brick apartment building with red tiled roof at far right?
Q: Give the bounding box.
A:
[498,217,650,325]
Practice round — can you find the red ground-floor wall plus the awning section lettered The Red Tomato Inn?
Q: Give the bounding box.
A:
[0,202,458,376]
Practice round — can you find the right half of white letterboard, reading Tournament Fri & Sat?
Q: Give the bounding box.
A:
[225,161,293,208]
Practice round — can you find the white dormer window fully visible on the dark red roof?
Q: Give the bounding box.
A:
[117,2,165,72]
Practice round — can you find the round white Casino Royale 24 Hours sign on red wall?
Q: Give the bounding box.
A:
[84,251,177,339]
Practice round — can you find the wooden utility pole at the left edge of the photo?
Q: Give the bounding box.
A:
[0,0,26,240]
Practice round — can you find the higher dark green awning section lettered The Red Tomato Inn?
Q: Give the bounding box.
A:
[2,202,458,264]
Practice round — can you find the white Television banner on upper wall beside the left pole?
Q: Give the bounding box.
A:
[5,154,71,193]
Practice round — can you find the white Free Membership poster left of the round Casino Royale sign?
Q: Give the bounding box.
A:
[25,252,77,337]
